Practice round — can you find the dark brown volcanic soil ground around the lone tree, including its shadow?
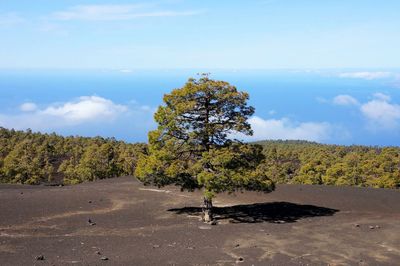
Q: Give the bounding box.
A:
[0,177,400,265]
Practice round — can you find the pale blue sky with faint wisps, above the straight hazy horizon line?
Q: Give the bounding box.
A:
[0,0,400,69]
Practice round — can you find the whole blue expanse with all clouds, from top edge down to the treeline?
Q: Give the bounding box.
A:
[0,0,400,145]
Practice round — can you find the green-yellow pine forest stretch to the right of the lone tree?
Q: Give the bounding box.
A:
[258,141,400,188]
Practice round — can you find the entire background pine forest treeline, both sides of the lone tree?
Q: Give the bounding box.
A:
[0,127,400,188]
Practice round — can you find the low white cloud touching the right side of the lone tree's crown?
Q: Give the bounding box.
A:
[241,116,334,142]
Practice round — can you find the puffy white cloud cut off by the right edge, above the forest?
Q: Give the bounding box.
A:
[360,93,400,129]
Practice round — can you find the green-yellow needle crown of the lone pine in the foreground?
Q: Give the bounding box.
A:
[135,75,274,199]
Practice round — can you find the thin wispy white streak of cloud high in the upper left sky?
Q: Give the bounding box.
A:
[51,4,199,21]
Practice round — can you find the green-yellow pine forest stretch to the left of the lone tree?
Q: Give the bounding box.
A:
[0,128,146,184]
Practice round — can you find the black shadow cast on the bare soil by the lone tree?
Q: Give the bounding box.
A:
[168,202,339,223]
